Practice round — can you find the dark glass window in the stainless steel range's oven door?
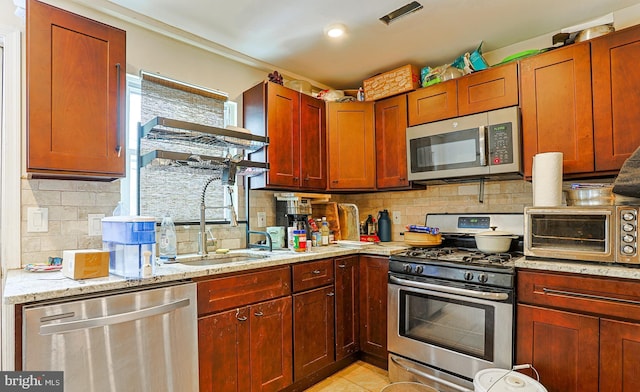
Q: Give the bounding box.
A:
[398,290,495,362]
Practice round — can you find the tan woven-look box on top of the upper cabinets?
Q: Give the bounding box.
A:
[363,64,420,101]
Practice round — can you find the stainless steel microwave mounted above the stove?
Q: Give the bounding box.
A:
[407,106,522,182]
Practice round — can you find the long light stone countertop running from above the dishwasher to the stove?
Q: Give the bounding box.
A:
[3,242,407,305]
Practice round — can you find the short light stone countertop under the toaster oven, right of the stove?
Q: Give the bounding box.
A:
[515,257,640,280]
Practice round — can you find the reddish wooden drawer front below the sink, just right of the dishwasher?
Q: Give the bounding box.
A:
[198,266,291,315]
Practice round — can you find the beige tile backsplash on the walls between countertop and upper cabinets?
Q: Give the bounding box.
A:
[21,179,532,265]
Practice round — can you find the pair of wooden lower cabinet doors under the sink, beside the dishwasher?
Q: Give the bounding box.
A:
[198,297,293,392]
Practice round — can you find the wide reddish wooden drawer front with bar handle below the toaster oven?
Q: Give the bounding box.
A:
[517,270,640,320]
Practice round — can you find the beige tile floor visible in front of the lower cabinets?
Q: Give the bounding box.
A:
[305,361,390,392]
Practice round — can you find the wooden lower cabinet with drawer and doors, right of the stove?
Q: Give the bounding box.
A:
[516,270,640,392]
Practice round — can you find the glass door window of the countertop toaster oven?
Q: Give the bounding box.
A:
[530,214,608,253]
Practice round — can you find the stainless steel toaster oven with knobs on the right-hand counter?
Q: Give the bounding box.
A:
[524,205,640,264]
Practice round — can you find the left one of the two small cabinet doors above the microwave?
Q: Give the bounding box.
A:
[407,80,458,126]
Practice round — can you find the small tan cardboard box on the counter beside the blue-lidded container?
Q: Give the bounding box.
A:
[62,249,109,279]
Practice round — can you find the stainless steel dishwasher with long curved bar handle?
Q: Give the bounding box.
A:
[22,282,198,392]
